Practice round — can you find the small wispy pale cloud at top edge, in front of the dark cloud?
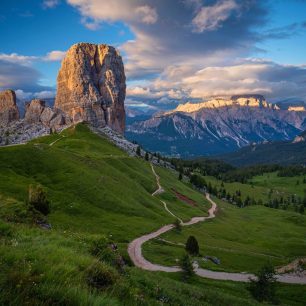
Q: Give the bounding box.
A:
[192,0,239,33]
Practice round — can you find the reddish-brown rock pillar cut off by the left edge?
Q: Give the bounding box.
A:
[0,90,19,126]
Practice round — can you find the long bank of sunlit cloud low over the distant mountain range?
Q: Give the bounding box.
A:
[127,58,306,105]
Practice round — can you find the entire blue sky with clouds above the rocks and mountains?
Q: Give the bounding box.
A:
[0,0,306,108]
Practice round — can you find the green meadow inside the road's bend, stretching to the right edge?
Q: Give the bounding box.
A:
[144,199,306,272]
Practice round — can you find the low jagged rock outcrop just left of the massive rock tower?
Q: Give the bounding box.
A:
[24,99,71,130]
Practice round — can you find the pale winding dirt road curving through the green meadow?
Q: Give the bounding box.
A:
[128,164,306,284]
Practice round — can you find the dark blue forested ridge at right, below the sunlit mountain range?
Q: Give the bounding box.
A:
[220,131,306,167]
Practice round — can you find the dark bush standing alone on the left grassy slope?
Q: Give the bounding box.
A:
[28,185,50,216]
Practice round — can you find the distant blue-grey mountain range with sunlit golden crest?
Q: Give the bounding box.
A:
[126,95,306,158]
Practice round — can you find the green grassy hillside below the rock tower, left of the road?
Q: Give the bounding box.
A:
[0,125,304,306]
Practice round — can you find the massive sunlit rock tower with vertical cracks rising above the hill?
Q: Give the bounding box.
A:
[55,43,126,134]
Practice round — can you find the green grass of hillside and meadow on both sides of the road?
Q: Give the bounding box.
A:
[0,125,306,306]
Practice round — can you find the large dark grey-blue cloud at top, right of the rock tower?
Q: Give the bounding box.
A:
[68,0,268,79]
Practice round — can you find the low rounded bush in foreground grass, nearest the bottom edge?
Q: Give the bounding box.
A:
[86,260,119,289]
